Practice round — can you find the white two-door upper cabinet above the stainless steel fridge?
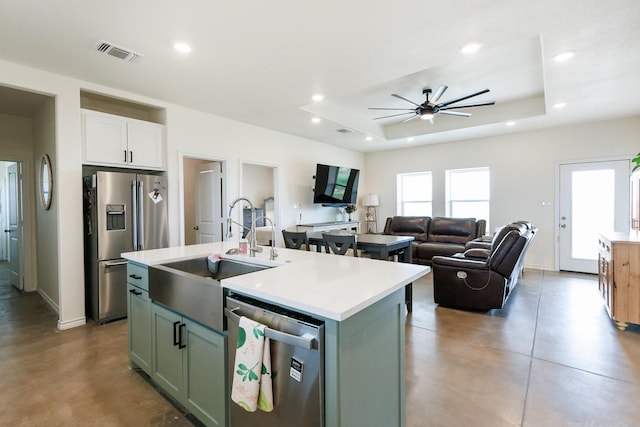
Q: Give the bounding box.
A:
[82,110,165,170]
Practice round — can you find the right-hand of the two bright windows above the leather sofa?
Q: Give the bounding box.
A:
[446,168,491,230]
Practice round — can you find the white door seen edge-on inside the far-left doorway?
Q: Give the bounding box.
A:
[7,163,22,289]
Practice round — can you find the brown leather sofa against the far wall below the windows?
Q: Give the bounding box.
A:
[383,216,487,265]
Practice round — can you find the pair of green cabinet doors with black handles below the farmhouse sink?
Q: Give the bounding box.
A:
[151,303,228,426]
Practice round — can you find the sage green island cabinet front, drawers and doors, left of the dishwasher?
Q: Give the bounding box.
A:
[127,262,228,426]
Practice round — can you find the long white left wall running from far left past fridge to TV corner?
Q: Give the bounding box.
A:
[0,61,366,329]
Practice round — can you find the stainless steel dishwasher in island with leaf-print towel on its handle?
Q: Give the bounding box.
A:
[225,295,324,427]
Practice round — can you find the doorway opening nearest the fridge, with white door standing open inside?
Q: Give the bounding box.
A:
[180,154,227,245]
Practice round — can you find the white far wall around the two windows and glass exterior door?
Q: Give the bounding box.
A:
[366,117,640,269]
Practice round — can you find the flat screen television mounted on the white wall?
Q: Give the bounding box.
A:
[313,163,360,207]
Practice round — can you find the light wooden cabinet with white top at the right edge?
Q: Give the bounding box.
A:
[598,232,640,331]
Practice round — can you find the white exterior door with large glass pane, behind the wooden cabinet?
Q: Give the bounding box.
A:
[558,160,629,274]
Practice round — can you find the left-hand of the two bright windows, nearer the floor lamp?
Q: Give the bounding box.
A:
[397,172,433,216]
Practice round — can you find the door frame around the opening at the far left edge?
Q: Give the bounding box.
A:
[0,154,38,292]
